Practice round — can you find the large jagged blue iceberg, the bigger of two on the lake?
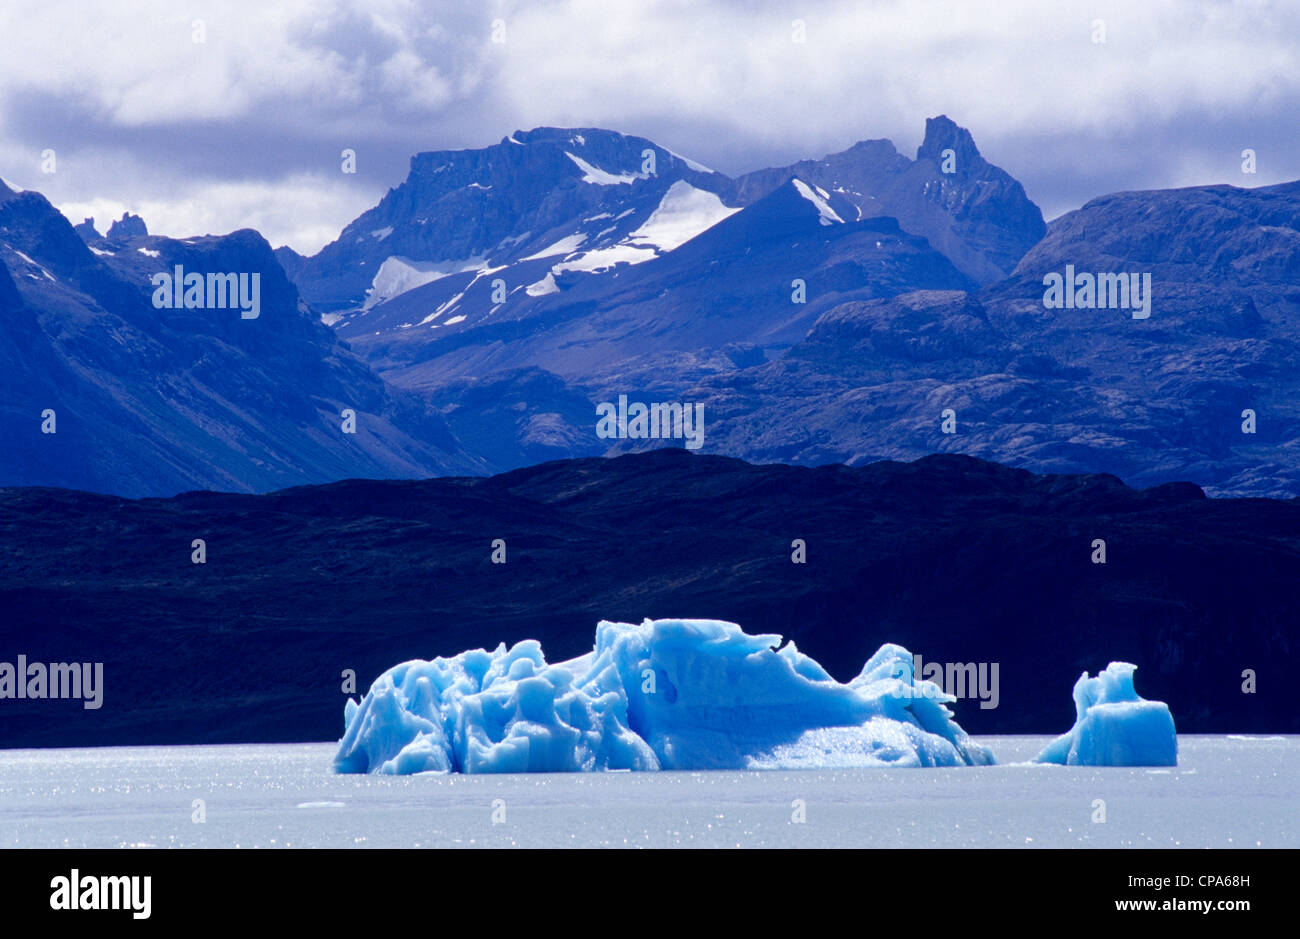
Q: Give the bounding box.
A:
[334,619,993,774]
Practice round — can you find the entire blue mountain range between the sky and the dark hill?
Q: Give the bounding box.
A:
[0,117,1300,497]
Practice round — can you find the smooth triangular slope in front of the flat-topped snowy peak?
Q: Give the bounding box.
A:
[339,179,974,393]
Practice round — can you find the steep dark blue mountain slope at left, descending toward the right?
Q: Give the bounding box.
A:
[0,179,482,496]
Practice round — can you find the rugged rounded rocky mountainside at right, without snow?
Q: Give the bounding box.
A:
[684,183,1300,496]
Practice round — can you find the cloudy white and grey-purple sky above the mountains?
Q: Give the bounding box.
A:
[0,0,1300,254]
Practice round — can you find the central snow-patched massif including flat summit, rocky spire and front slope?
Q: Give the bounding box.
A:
[278,117,1044,476]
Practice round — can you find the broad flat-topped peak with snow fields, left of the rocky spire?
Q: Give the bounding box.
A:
[281,127,733,320]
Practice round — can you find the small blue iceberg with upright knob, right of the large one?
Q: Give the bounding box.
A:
[1034,662,1178,766]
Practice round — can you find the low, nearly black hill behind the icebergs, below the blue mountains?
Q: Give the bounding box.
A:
[0,450,1300,747]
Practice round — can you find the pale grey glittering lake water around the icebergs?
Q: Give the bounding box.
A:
[0,736,1300,848]
